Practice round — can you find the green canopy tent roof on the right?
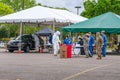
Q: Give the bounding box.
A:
[62,12,120,33]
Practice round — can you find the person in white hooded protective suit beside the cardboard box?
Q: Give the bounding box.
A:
[52,31,61,56]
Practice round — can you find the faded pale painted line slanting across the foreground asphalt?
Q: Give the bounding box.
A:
[62,64,113,80]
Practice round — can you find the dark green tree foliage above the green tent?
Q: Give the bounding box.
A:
[81,0,120,18]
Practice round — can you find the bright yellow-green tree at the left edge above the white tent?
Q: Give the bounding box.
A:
[0,2,13,16]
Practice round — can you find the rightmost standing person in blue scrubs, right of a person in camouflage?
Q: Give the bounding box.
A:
[101,31,107,57]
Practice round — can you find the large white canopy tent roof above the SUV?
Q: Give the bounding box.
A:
[0,6,87,23]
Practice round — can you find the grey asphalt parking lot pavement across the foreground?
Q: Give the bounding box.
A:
[0,52,120,80]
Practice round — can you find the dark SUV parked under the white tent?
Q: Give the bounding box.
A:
[7,35,44,52]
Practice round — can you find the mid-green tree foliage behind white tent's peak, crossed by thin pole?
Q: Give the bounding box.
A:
[0,0,36,12]
